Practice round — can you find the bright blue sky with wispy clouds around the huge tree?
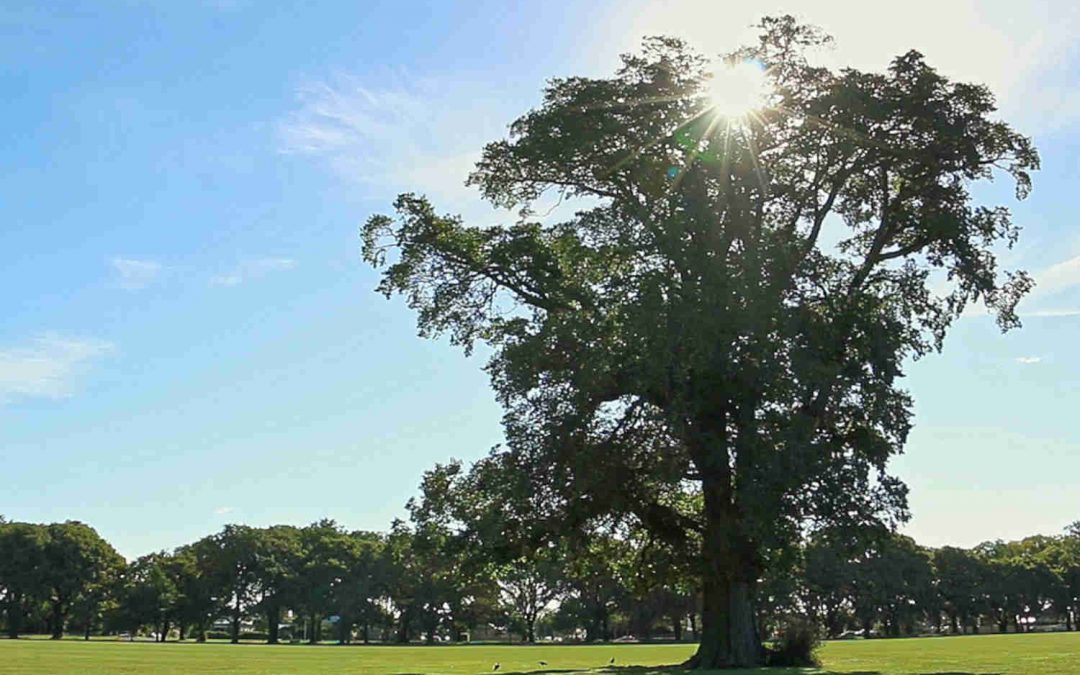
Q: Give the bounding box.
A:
[0,0,1080,556]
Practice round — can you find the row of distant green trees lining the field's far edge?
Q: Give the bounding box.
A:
[0,479,1080,644]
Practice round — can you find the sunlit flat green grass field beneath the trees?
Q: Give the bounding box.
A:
[0,633,1080,675]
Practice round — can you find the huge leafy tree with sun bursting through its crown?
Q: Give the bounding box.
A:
[363,17,1038,666]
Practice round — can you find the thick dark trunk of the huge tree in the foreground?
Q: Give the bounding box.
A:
[689,468,765,669]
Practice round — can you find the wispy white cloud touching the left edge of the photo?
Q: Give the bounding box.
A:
[0,333,112,405]
